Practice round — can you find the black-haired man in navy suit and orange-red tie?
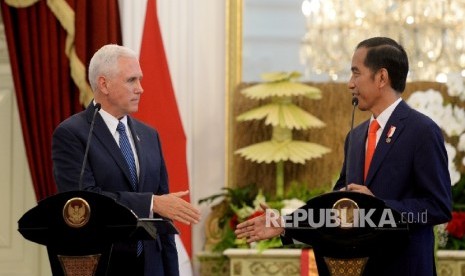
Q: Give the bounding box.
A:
[236,37,452,276]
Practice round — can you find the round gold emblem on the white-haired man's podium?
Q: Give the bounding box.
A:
[63,197,90,228]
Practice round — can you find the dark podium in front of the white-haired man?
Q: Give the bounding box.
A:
[18,191,177,276]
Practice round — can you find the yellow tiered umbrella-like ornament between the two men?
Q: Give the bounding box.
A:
[235,72,330,199]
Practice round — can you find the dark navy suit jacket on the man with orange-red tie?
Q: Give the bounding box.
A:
[334,101,452,276]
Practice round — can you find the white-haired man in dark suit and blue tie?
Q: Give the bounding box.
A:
[52,45,200,275]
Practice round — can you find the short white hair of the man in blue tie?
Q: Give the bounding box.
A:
[88,44,137,92]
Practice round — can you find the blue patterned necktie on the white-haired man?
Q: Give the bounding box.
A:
[116,121,144,256]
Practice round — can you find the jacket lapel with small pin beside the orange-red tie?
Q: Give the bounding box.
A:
[365,101,409,186]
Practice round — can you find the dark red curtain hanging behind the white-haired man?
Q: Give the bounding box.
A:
[1,0,121,200]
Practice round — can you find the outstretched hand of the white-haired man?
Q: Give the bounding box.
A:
[153,191,200,225]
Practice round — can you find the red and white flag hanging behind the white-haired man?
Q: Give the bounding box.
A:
[120,0,192,270]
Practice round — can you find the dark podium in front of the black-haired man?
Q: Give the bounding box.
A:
[285,192,408,276]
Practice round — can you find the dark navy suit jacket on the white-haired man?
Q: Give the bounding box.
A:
[52,103,179,275]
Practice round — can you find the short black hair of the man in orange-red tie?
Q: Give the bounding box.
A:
[357,37,409,93]
